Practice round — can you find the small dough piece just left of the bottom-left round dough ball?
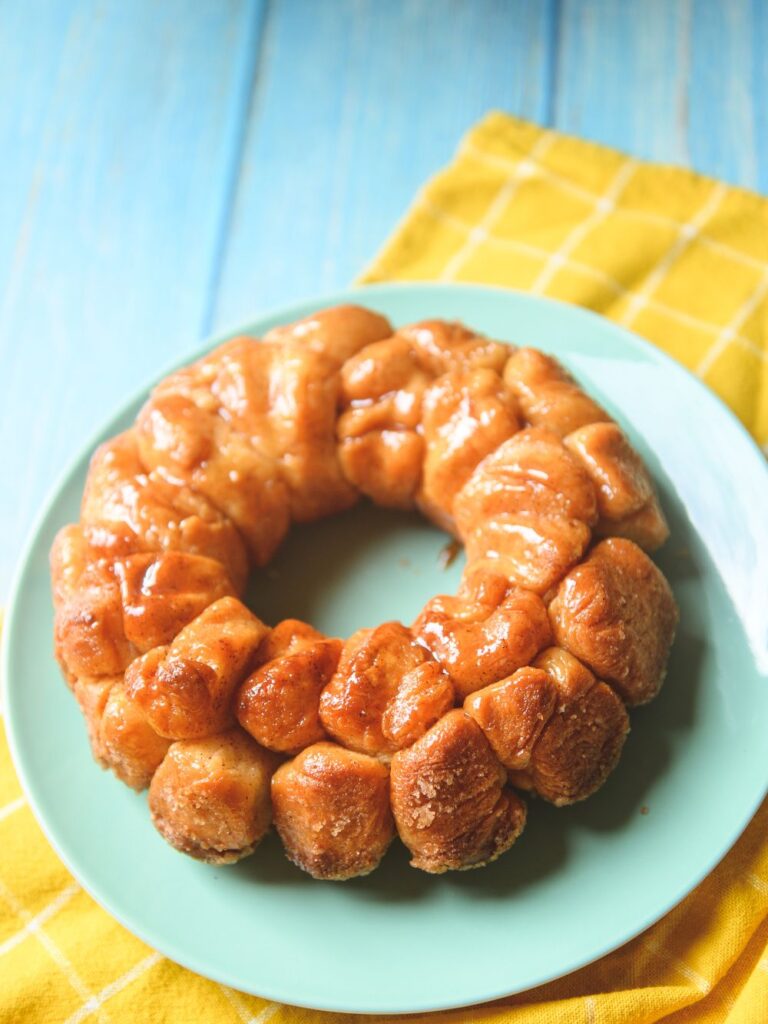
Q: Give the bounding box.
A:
[98,680,171,790]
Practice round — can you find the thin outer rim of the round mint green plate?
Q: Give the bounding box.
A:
[6,281,768,1015]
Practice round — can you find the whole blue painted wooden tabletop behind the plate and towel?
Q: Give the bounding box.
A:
[0,0,768,601]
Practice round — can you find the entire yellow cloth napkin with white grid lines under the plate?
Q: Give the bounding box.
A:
[0,114,768,1024]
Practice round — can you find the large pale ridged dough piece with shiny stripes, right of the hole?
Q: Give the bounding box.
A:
[454,427,597,594]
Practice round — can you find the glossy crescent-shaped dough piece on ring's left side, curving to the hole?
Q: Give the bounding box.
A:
[80,430,248,593]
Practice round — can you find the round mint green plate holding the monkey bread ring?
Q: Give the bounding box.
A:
[4,285,768,1013]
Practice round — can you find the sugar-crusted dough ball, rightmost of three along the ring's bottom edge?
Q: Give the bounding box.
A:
[391,710,525,874]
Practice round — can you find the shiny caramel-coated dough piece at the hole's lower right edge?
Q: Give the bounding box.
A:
[413,571,552,697]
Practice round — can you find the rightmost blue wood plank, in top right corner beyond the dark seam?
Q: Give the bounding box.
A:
[554,0,768,191]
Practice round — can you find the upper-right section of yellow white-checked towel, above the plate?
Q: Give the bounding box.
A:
[365,114,768,445]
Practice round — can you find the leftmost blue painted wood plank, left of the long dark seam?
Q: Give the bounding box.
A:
[0,0,262,599]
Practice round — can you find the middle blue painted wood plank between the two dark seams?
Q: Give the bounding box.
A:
[213,0,554,327]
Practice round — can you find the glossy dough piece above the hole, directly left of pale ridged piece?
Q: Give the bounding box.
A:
[418,367,520,534]
